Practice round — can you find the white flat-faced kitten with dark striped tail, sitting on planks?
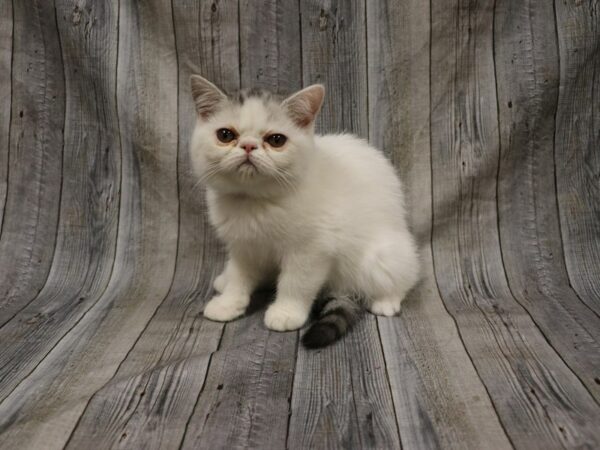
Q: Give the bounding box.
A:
[190,75,419,348]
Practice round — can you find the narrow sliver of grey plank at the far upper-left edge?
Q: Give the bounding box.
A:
[0,0,13,232]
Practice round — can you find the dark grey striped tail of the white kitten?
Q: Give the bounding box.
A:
[302,295,363,348]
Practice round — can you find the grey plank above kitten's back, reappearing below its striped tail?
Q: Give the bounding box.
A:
[288,1,400,448]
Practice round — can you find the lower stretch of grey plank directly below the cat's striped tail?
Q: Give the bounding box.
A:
[288,317,400,449]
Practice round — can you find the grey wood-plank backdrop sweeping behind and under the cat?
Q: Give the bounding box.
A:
[0,0,600,450]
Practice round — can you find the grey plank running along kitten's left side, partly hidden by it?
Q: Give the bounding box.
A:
[68,1,239,449]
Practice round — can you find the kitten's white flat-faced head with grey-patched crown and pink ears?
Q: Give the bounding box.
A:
[190,75,325,197]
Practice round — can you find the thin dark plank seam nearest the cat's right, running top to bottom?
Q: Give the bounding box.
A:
[429,0,515,448]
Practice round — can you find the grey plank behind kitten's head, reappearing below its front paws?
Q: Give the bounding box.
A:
[183,0,301,448]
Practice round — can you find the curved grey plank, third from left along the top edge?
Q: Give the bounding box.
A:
[0,2,121,399]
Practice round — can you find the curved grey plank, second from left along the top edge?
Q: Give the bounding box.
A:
[0,1,65,326]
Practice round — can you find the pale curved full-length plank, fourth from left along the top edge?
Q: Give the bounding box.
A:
[0,0,178,448]
